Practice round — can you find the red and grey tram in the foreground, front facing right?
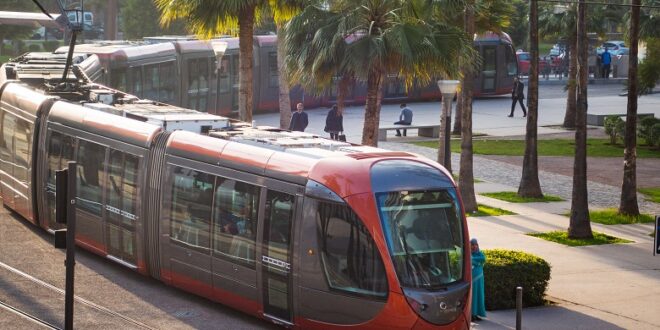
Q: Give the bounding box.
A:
[0,54,471,329]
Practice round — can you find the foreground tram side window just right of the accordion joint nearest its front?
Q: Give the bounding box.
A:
[170,166,214,251]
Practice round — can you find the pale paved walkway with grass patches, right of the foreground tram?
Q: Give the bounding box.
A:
[381,143,660,329]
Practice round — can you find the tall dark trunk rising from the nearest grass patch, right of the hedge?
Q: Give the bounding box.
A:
[568,0,593,238]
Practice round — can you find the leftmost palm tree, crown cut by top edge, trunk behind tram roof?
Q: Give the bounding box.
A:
[154,0,298,122]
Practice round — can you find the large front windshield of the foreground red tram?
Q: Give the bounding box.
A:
[376,188,463,290]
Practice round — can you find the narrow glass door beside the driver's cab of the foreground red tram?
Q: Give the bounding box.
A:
[261,190,295,322]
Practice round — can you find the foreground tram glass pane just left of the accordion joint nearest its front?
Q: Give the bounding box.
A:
[106,150,139,226]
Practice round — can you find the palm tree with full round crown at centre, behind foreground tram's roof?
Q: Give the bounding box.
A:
[286,0,475,146]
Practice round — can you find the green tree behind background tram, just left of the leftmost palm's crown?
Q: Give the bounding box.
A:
[119,0,188,39]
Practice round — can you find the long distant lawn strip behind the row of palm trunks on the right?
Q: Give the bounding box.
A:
[413,139,660,158]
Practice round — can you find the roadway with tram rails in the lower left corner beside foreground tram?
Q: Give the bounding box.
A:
[0,208,274,329]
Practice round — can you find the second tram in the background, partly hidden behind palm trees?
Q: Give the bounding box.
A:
[57,33,518,116]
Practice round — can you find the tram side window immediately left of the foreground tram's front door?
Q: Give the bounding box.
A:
[213,178,259,267]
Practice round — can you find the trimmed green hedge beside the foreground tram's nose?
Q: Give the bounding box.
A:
[483,249,550,310]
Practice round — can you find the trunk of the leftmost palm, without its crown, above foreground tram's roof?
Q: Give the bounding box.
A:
[238,5,256,123]
